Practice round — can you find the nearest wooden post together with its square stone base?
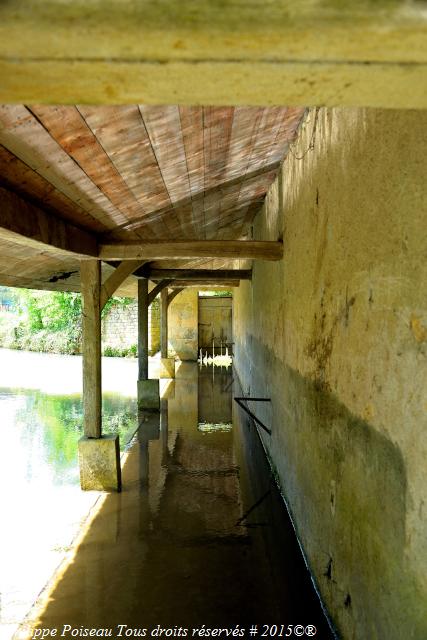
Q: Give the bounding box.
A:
[79,259,121,491]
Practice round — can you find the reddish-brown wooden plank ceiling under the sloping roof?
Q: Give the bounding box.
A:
[0,105,304,293]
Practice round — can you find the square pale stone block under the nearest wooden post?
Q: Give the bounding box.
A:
[79,436,122,491]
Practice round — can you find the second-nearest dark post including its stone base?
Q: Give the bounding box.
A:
[138,278,160,411]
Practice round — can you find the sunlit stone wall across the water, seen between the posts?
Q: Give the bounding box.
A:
[102,298,160,355]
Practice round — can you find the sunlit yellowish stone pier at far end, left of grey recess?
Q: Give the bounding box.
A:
[168,288,199,360]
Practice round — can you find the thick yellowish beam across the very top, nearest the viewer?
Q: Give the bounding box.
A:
[0,0,427,108]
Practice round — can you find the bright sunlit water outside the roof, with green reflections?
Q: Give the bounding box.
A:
[0,349,137,640]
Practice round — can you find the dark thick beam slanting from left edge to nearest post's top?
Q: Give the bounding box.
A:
[0,187,98,258]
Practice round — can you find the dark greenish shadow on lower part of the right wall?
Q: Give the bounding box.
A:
[246,339,416,639]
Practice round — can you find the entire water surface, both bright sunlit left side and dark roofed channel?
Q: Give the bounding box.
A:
[0,352,332,639]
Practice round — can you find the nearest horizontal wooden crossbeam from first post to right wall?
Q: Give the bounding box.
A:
[99,240,283,260]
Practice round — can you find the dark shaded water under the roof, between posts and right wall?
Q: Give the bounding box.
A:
[28,363,332,639]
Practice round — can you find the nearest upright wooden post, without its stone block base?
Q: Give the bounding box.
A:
[80,259,102,438]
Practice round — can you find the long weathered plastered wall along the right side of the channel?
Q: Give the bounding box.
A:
[234,109,427,640]
